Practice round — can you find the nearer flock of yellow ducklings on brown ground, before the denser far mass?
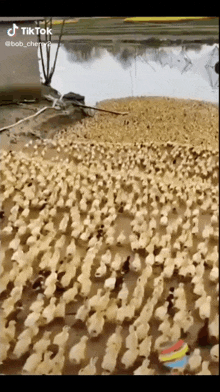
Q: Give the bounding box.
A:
[0,97,219,375]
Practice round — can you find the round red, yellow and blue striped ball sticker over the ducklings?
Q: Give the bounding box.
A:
[159,339,189,374]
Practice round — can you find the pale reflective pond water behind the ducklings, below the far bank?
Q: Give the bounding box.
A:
[39,41,219,105]
